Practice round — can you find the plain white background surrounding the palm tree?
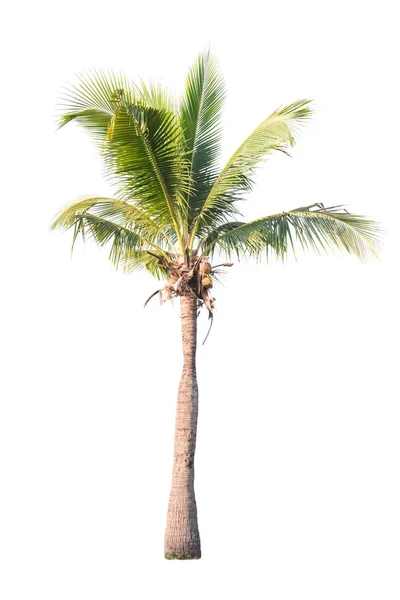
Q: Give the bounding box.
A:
[0,0,400,600]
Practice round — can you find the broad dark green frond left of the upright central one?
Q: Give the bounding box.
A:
[106,103,189,238]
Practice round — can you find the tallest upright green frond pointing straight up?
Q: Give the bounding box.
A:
[180,52,225,229]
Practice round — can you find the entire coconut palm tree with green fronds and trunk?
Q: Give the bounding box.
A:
[52,52,379,559]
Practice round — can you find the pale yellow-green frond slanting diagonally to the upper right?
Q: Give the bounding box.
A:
[192,100,311,244]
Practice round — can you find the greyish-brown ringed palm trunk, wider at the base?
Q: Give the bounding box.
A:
[164,294,201,560]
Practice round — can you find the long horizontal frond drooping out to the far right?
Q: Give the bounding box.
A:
[202,204,380,260]
